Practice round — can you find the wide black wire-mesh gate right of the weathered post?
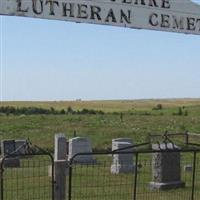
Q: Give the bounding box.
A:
[68,139,200,200]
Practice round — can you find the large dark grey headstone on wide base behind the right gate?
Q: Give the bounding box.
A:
[150,143,185,190]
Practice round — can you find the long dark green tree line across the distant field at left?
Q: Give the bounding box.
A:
[0,106,104,115]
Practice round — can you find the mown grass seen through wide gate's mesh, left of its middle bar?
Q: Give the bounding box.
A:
[68,155,134,200]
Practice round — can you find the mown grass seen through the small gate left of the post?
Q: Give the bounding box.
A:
[3,156,52,200]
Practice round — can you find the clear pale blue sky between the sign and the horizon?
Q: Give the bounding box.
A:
[1,17,200,101]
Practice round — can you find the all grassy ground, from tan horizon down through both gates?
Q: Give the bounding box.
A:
[0,99,200,200]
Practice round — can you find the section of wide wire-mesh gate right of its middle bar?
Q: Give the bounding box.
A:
[135,150,200,200]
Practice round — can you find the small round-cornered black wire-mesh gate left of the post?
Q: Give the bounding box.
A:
[0,142,54,200]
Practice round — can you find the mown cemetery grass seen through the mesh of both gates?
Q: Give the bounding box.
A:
[4,154,200,200]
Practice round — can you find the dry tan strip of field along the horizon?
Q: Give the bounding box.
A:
[0,99,200,112]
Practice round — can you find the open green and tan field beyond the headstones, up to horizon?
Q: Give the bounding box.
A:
[0,99,200,149]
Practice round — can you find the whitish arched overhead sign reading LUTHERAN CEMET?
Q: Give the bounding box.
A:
[0,0,200,34]
